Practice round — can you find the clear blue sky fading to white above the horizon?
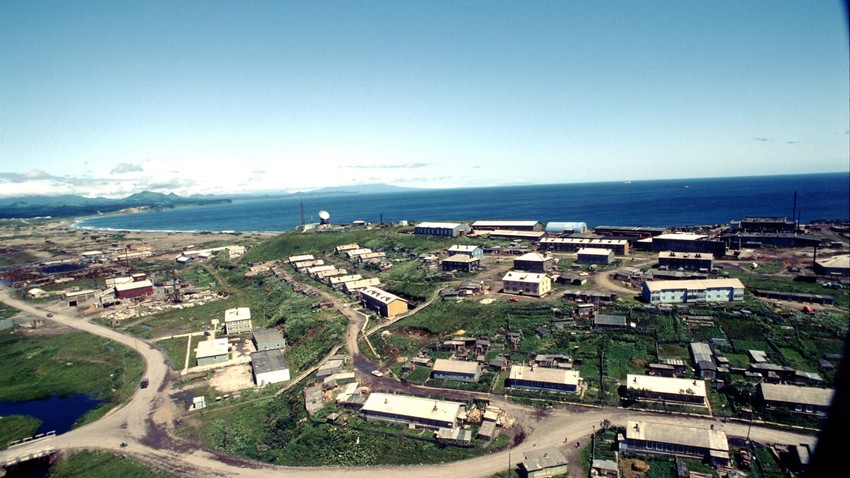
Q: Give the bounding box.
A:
[0,0,850,197]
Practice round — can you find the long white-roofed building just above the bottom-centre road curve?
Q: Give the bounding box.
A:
[360,393,466,429]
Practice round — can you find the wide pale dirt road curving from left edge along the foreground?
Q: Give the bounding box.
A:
[0,288,813,478]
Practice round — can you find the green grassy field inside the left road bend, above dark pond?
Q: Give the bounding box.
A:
[0,332,144,423]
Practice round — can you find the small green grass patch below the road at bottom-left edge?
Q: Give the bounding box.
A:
[50,451,175,478]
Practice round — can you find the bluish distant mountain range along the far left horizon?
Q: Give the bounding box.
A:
[0,191,231,219]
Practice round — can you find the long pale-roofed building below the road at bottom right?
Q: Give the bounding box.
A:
[619,421,730,466]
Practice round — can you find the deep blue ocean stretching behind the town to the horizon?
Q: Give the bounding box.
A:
[76,173,850,232]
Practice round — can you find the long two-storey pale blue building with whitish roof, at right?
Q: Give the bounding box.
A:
[643,279,744,304]
